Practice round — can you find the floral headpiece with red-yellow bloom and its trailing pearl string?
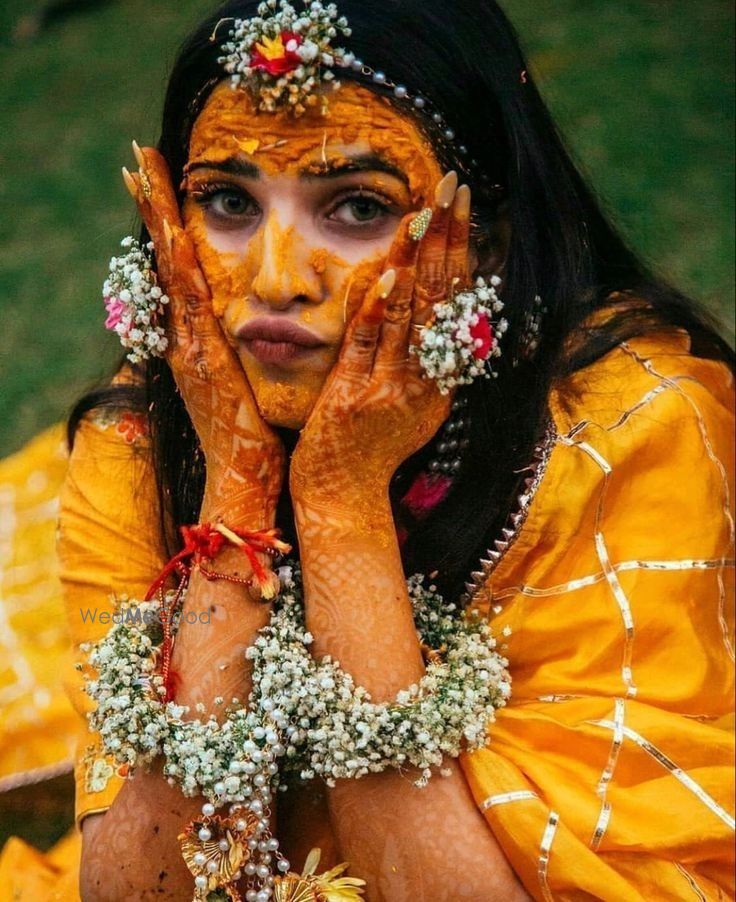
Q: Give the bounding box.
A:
[210,0,478,177]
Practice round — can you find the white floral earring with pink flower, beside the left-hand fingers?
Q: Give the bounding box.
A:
[102,236,169,363]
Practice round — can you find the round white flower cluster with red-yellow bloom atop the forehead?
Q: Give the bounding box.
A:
[218,0,353,116]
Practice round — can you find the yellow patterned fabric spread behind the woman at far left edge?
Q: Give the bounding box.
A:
[0,425,78,795]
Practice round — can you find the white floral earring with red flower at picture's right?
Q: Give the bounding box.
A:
[411,276,508,395]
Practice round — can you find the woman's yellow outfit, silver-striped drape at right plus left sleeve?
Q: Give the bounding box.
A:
[0,335,734,902]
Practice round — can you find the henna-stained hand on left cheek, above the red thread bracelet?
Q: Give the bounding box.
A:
[123,143,285,529]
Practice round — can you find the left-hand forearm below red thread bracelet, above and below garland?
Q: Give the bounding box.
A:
[81,549,269,902]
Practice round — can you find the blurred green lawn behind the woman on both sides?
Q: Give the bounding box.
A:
[0,0,734,454]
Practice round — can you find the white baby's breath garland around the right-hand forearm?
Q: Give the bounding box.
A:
[247,567,510,786]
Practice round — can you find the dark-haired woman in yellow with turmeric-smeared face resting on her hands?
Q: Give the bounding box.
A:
[49,0,733,902]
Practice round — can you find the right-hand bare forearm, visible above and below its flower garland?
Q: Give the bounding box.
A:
[296,496,526,902]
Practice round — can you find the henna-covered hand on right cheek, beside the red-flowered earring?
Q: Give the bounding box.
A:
[290,172,470,509]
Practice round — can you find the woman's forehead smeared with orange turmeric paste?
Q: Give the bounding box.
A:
[189,82,442,201]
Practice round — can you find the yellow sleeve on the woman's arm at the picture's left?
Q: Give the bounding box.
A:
[58,413,163,824]
